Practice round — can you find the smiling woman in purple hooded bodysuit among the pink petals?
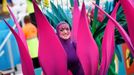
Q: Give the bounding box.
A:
[56,22,84,75]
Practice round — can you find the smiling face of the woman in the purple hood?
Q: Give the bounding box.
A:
[58,23,71,40]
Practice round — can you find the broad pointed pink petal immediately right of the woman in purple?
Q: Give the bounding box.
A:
[77,3,99,75]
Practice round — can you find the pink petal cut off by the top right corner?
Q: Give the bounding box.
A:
[120,0,134,50]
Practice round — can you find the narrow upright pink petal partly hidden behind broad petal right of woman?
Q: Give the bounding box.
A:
[71,0,80,42]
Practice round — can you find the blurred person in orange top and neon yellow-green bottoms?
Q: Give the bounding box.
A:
[22,15,40,68]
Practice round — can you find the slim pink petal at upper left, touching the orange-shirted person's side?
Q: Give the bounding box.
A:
[7,6,28,50]
